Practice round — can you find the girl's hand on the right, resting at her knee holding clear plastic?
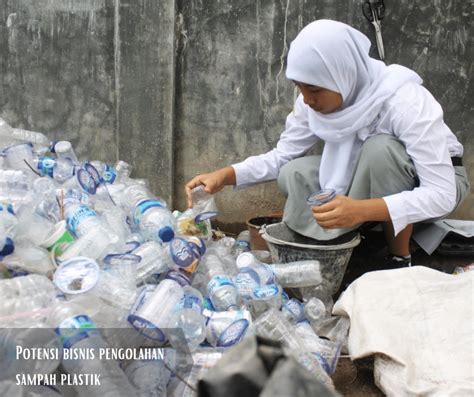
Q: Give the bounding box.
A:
[311,195,364,229]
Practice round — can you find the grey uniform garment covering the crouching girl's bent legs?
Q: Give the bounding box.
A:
[278,134,469,240]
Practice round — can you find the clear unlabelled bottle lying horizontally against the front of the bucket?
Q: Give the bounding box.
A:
[268,260,323,288]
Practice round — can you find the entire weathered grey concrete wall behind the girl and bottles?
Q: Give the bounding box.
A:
[0,0,474,224]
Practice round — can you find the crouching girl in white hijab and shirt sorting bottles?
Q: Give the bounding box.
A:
[186,20,469,267]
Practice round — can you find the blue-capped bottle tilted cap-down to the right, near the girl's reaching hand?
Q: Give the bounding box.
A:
[124,185,175,243]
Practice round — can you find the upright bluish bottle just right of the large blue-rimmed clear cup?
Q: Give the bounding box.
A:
[170,286,206,351]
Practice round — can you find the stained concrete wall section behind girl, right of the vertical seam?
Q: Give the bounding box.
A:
[175,0,474,223]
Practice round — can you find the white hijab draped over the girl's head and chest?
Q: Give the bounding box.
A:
[286,19,423,193]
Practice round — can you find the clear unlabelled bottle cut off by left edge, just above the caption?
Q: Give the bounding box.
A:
[0,274,56,328]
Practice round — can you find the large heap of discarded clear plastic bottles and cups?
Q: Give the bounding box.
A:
[0,119,349,396]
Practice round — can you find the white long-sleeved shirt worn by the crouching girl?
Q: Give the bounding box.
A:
[232,83,463,235]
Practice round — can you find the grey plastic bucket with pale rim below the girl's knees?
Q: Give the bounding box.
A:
[260,222,360,294]
